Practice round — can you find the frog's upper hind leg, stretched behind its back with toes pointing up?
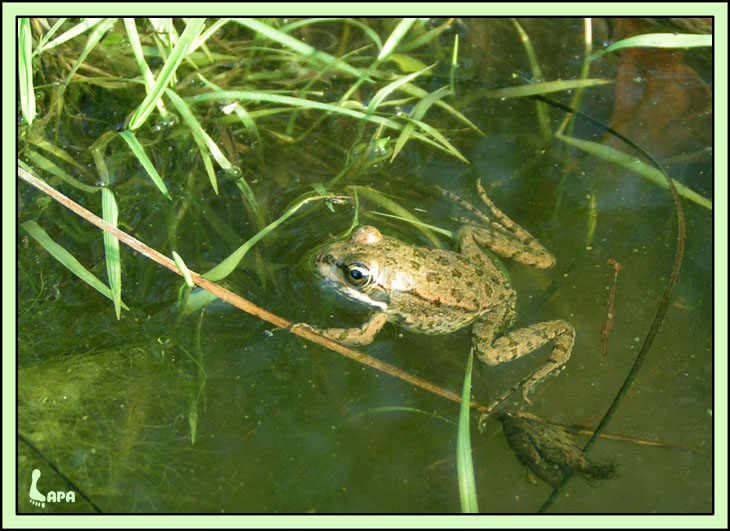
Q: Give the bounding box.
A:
[443,179,555,269]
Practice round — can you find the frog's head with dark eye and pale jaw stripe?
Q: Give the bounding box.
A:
[314,226,388,311]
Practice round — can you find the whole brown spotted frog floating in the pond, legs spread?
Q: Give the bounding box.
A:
[296,180,575,403]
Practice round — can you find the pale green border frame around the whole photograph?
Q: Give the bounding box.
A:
[2,2,728,528]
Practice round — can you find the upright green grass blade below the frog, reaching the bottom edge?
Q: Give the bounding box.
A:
[456,348,479,513]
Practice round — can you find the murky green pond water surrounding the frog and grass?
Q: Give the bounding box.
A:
[17,19,713,513]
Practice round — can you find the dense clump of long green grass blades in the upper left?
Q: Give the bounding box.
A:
[18,18,475,316]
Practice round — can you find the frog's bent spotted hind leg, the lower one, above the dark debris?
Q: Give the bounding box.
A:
[472,312,575,403]
